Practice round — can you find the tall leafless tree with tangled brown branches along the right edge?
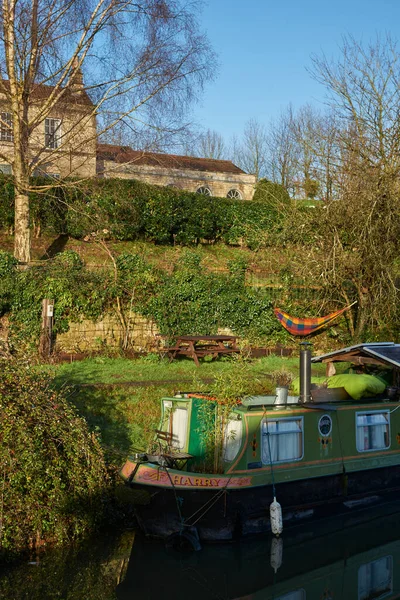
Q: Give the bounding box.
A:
[313,36,400,338]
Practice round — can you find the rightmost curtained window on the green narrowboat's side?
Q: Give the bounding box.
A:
[356,411,390,452]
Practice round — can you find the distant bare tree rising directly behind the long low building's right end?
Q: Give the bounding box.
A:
[232,119,268,181]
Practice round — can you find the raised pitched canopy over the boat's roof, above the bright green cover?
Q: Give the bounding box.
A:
[311,342,400,369]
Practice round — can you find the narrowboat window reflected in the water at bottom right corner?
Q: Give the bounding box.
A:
[358,556,393,600]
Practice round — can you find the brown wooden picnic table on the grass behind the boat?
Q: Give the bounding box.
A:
[165,335,240,366]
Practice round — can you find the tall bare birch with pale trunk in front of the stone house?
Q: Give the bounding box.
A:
[0,0,214,263]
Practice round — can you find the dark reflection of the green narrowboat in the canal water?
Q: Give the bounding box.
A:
[117,507,400,600]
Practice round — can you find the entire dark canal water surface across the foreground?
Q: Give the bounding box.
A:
[0,503,400,600]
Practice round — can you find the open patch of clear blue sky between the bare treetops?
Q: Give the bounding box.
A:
[194,0,400,141]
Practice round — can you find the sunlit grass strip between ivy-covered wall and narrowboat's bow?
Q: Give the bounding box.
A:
[49,355,325,465]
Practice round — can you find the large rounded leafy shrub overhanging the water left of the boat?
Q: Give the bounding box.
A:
[0,361,108,553]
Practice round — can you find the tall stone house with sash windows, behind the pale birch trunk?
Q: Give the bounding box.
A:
[0,73,97,178]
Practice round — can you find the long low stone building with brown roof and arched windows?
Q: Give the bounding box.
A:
[97,144,256,200]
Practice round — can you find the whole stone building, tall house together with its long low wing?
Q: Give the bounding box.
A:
[0,71,256,200]
